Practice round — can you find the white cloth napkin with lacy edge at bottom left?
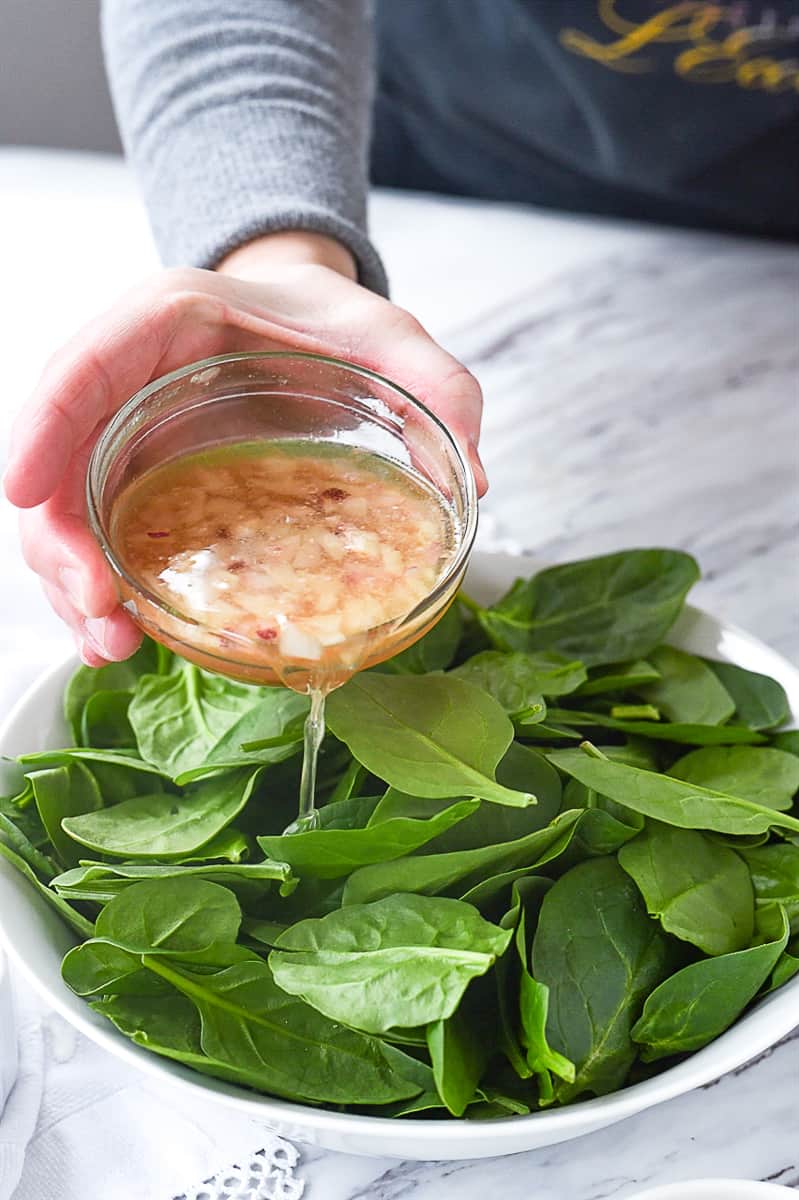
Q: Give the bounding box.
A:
[0,979,304,1200]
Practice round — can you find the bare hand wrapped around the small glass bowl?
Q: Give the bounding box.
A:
[5,233,486,666]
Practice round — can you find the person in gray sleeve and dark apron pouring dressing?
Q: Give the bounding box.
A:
[5,0,799,666]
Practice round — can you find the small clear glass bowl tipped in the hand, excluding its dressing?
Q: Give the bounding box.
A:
[86,352,477,691]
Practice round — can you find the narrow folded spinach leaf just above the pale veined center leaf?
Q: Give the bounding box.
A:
[342,812,579,906]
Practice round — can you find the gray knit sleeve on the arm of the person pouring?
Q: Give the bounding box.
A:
[103,0,386,293]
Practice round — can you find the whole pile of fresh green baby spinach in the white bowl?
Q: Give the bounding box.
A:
[0,550,799,1120]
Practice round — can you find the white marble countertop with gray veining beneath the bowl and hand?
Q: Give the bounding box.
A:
[0,150,799,1200]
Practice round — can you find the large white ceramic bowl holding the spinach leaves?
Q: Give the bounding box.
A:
[0,553,799,1159]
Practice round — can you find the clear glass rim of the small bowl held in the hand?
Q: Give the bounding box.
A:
[85,350,477,666]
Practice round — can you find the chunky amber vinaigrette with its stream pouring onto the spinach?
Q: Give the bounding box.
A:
[112,440,456,828]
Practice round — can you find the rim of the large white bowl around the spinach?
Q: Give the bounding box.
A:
[0,585,799,1157]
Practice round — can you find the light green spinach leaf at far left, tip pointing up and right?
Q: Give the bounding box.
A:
[62,767,258,858]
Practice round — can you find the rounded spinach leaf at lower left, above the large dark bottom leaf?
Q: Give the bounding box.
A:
[94,877,241,955]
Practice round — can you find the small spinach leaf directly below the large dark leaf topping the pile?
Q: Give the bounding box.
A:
[451,650,587,714]
